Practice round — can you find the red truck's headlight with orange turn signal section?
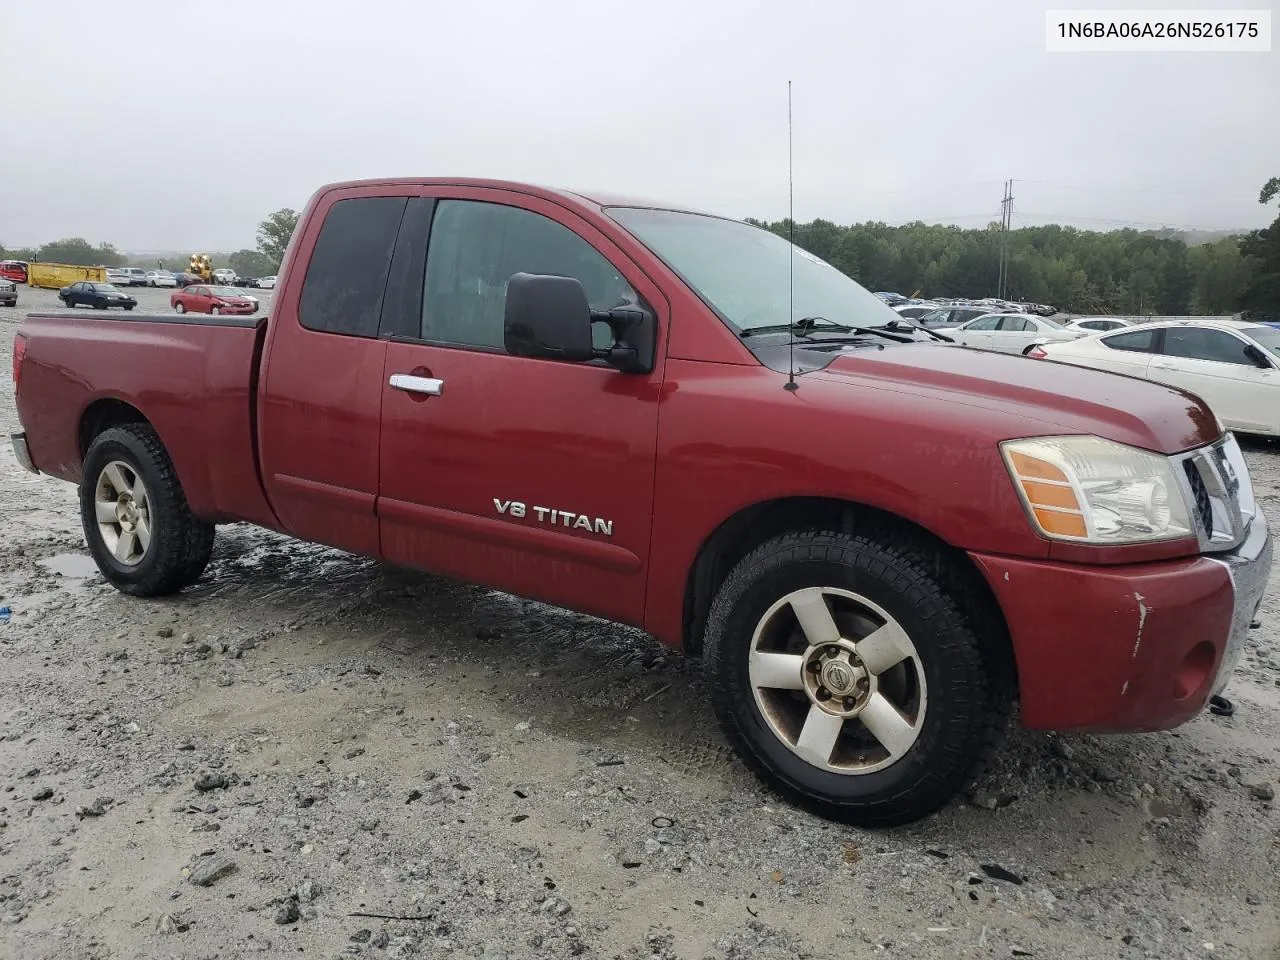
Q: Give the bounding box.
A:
[1000,436,1193,544]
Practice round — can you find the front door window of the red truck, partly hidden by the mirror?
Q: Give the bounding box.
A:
[422,200,639,349]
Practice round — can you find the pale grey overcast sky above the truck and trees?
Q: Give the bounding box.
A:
[0,0,1280,251]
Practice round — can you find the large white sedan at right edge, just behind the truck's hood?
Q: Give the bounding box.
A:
[1030,320,1280,436]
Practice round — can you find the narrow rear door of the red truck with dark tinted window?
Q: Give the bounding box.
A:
[259,187,408,557]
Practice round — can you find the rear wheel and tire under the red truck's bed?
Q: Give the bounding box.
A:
[79,424,214,596]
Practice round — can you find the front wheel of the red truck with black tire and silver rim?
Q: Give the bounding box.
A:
[705,531,1012,827]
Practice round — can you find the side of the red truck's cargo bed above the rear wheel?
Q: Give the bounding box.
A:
[18,312,276,527]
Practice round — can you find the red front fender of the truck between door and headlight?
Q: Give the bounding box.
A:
[645,360,1048,644]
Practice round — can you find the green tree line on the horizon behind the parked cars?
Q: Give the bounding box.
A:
[0,185,1280,319]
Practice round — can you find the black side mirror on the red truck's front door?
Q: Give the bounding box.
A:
[503,274,658,374]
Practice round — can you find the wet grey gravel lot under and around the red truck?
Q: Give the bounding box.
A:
[0,288,1280,960]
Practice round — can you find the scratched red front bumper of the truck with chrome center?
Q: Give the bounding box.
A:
[970,509,1272,732]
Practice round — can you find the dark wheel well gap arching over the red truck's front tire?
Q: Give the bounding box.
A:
[684,497,1016,684]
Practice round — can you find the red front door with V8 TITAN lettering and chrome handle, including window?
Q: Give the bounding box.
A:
[378,187,668,623]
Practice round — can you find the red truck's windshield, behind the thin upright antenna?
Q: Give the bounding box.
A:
[608,207,901,333]
